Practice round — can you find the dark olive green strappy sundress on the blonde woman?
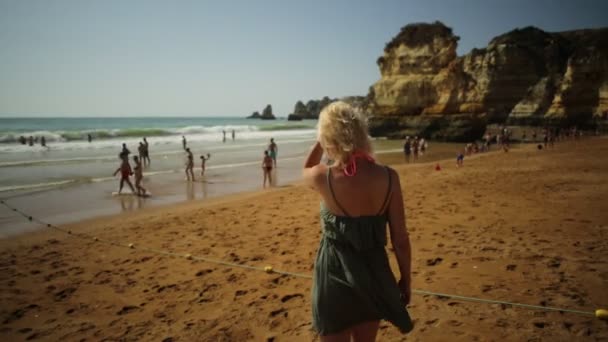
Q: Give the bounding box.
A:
[312,168,413,335]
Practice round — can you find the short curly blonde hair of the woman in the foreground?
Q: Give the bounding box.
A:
[318,101,372,165]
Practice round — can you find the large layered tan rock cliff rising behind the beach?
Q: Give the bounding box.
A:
[368,22,608,141]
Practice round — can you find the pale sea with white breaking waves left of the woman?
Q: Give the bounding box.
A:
[0,117,316,195]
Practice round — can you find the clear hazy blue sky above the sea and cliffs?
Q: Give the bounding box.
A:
[0,0,608,116]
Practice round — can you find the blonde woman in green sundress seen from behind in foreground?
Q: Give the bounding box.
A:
[303,101,413,341]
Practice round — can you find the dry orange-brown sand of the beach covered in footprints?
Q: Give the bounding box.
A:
[0,138,608,341]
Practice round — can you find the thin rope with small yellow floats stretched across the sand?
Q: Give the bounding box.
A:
[0,199,608,320]
